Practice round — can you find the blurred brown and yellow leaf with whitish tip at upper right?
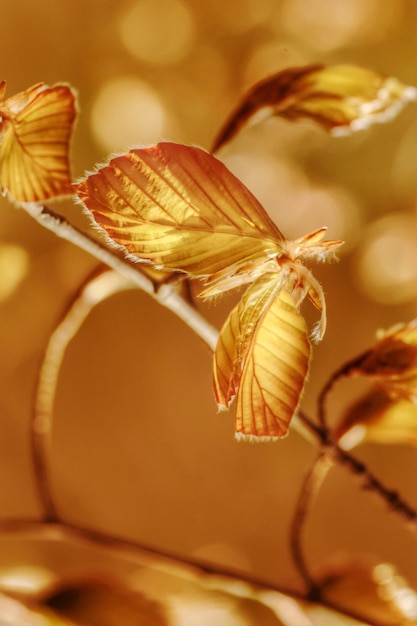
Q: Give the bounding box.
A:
[213,65,417,152]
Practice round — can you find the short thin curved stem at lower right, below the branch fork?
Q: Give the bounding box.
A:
[290,451,332,600]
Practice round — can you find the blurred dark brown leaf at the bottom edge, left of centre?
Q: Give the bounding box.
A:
[42,579,169,626]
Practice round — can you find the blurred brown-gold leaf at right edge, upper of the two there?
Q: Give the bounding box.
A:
[348,319,417,404]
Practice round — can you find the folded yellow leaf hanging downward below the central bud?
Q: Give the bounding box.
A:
[214,275,310,439]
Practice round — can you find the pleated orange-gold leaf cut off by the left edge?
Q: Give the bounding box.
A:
[0,81,76,202]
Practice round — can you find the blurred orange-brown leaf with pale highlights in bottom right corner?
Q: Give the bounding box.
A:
[320,562,417,626]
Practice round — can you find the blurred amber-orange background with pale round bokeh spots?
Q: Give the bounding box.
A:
[0,0,417,604]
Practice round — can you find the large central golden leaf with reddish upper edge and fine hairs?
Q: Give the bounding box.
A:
[76,143,284,277]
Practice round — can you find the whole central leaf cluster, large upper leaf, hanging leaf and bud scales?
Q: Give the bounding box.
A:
[75,143,342,437]
